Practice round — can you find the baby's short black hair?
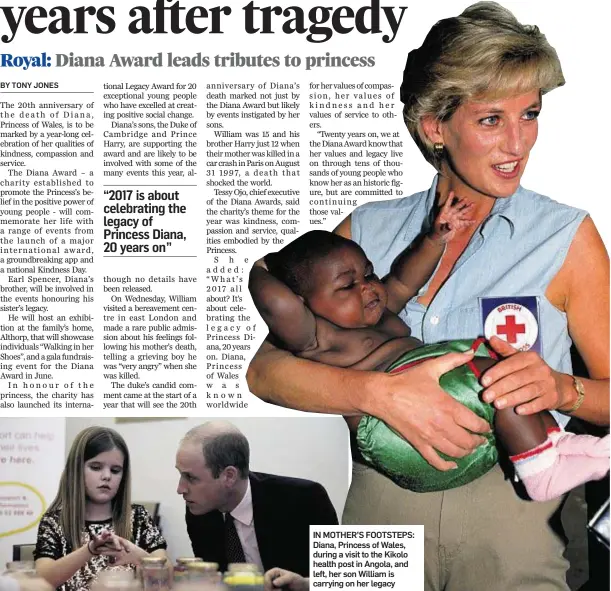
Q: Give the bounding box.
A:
[265,230,367,296]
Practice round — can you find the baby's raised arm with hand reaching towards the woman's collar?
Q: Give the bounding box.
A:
[384,191,474,312]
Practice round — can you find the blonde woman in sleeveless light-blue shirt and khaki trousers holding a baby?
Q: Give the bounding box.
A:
[248,2,609,591]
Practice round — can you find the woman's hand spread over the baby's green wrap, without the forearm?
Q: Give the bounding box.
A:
[365,351,490,471]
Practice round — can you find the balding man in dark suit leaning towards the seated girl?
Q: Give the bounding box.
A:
[176,421,337,577]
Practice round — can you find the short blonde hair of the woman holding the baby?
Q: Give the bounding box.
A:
[401,2,564,169]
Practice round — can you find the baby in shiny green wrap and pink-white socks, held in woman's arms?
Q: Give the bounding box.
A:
[249,193,609,500]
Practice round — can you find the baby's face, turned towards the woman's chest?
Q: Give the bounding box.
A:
[305,246,387,328]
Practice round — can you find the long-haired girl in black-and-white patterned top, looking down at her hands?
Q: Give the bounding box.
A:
[34,427,167,591]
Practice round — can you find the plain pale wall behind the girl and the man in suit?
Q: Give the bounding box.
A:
[66,417,350,558]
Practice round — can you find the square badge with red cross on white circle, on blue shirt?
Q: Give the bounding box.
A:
[480,296,541,353]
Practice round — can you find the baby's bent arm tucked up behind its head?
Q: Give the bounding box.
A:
[248,261,316,353]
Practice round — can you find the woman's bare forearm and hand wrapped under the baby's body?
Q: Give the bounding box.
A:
[247,341,490,470]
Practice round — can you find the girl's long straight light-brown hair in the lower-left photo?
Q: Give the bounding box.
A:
[49,427,132,550]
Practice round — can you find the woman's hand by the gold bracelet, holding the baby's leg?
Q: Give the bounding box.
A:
[481,336,568,415]
